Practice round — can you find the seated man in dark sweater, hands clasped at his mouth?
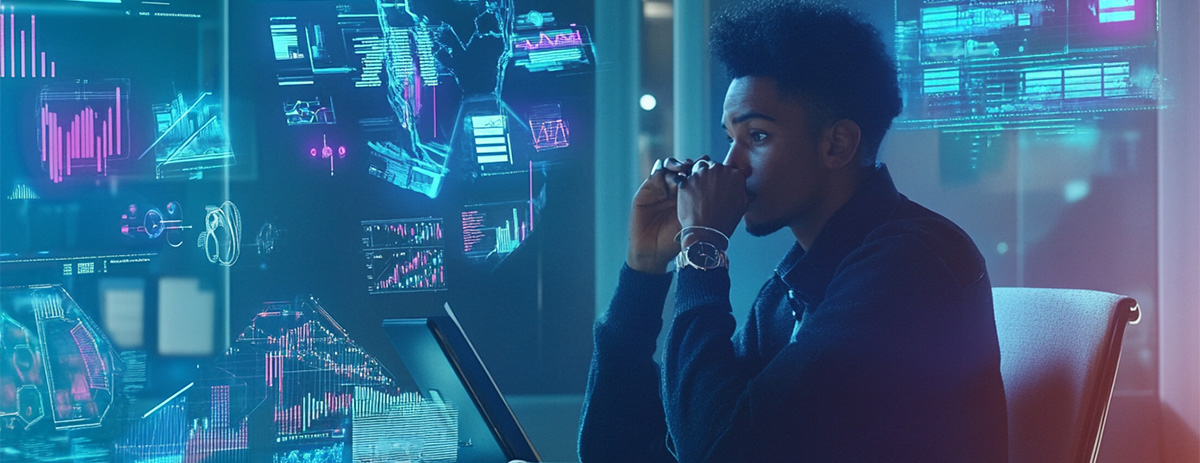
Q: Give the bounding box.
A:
[578,0,1008,462]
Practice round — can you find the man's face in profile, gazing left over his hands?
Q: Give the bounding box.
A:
[721,77,828,236]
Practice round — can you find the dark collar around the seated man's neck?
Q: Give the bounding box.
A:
[775,163,904,305]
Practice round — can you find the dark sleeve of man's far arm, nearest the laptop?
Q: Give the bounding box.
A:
[578,266,676,463]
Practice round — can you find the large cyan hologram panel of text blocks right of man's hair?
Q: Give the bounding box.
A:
[896,0,1162,131]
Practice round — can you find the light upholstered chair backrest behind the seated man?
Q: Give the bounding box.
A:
[992,288,1141,463]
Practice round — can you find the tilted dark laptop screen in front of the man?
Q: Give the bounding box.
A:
[383,305,540,463]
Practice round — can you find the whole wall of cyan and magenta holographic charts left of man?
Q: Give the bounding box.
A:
[0,0,595,463]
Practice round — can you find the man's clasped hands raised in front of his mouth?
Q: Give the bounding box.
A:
[626,156,746,273]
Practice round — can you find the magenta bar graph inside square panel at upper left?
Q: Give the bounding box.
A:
[41,86,121,184]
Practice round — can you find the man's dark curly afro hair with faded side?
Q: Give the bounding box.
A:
[709,0,902,160]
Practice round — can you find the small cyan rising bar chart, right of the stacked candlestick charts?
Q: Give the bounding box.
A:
[462,202,534,261]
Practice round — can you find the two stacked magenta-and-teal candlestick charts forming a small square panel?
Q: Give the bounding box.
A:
[362,217,446,294]
